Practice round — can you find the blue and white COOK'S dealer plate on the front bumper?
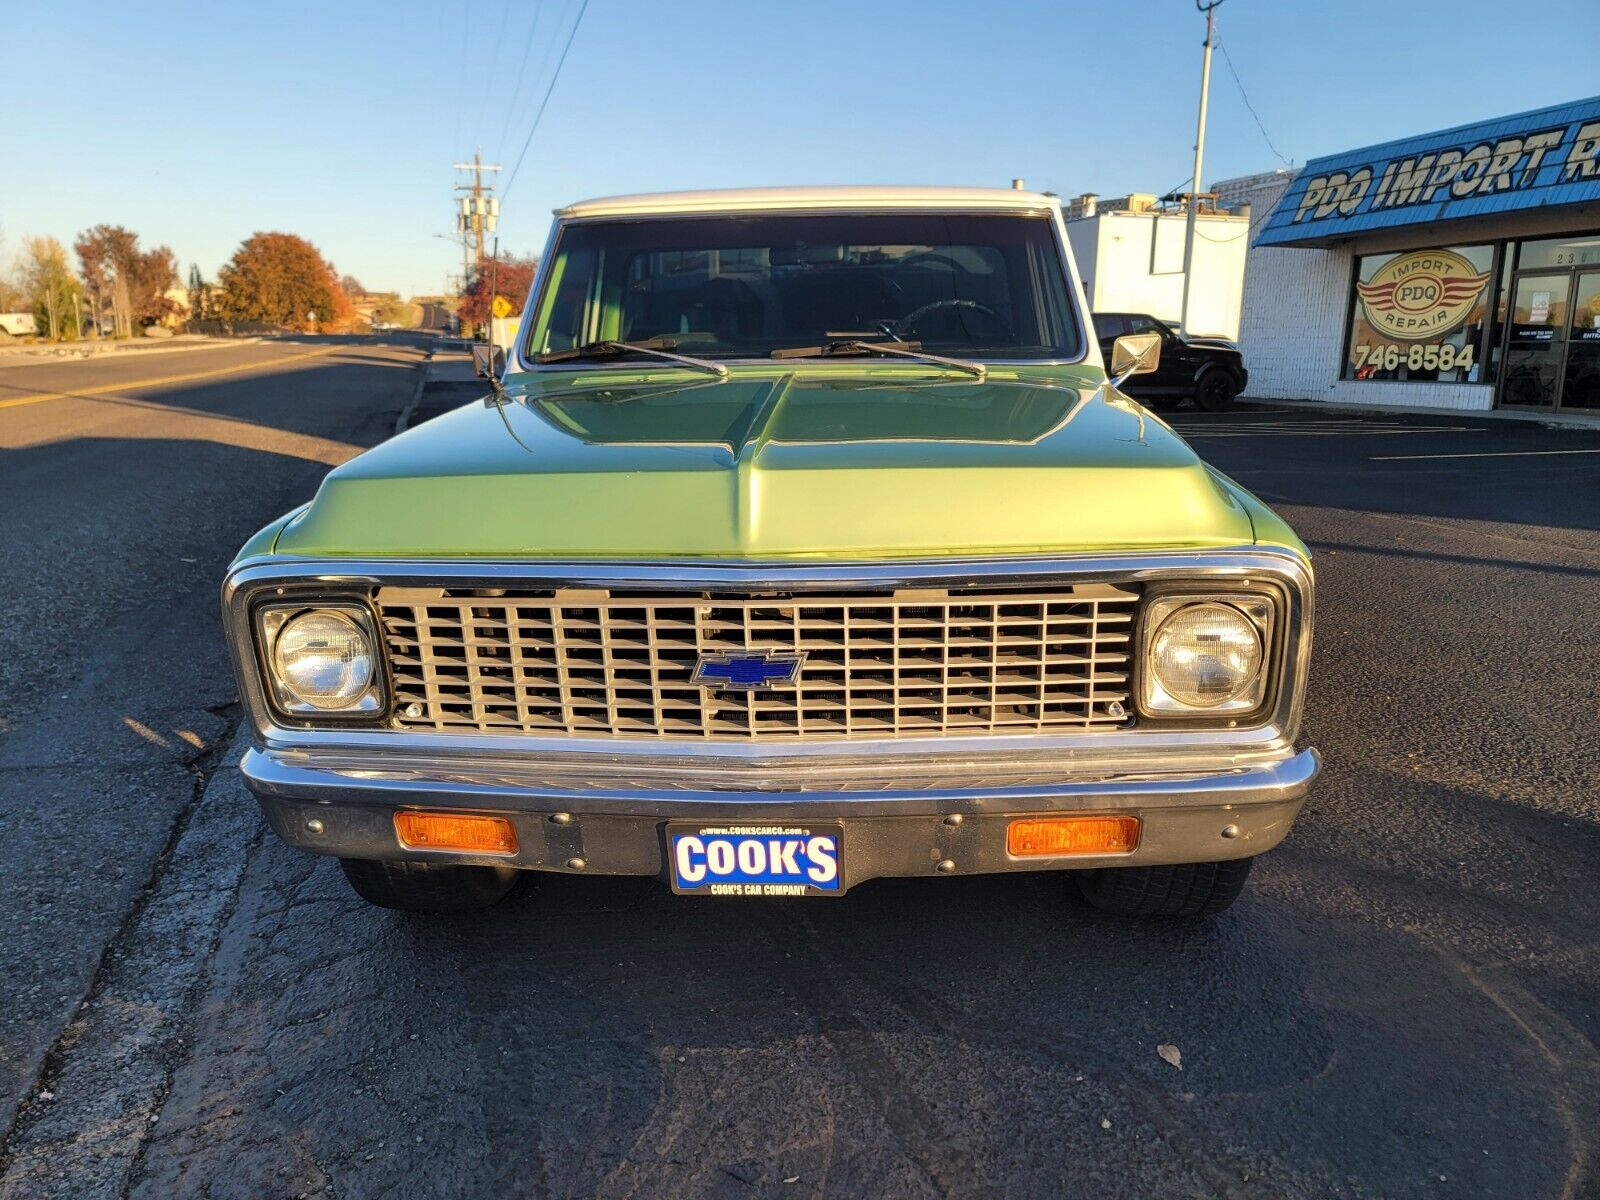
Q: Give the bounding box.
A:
[667,824,845,896]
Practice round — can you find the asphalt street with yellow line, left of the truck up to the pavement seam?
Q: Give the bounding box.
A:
[0,339,421,1177]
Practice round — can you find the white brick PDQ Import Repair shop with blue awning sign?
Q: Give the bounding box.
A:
[1241,96,1600,413]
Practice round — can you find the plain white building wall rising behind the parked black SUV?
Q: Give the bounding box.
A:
[1067,213,1248,339]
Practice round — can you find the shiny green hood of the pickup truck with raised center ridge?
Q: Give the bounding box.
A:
[275,363,1253,558]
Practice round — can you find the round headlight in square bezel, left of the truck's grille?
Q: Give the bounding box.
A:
[261,608,381,715]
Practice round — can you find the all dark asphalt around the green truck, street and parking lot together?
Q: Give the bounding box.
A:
[0,387,1600,1200]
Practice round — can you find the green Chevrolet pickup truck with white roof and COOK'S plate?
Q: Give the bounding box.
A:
[222,187,1317,917]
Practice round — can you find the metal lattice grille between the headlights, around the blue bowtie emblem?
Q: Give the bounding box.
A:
[376,584,1138,741]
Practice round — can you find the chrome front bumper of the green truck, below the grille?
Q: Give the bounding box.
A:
[242,747,1318,886]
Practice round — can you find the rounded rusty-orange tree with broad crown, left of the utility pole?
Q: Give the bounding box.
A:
[218,234,354,330]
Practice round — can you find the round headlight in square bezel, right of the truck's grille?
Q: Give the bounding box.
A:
[1141,597,1272,715]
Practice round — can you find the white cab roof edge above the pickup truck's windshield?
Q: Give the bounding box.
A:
[555,186,1061,221]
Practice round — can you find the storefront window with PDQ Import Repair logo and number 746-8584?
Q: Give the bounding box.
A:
[1344,245,1494,382]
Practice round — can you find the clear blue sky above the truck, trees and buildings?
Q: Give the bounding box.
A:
[0,0,1600,293]
